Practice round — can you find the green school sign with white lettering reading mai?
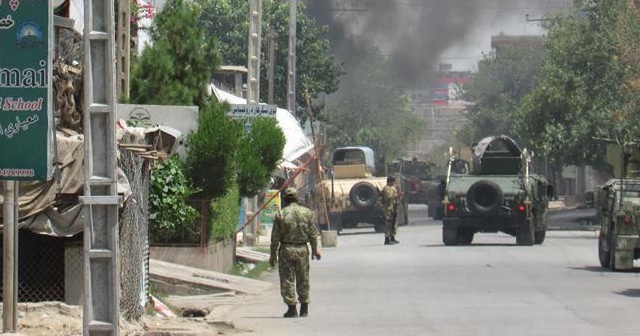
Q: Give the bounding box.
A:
[0,0,53,180]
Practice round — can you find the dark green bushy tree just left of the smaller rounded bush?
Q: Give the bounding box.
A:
[186,104,243,199]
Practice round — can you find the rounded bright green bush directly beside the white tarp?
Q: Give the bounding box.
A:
[237,118,286,197]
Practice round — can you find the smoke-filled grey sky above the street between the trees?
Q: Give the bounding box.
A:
[308,0,572,80]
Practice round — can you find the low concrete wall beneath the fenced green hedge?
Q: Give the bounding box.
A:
[150,238,236,273]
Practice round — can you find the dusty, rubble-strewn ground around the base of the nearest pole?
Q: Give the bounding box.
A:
[0,302,236,336]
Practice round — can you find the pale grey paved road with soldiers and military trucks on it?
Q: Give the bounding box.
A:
[227,206,640,336]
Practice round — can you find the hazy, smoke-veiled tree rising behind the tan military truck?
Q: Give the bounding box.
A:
[326,44,424,163]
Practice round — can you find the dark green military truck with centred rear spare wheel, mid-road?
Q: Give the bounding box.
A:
[442,135,553,245]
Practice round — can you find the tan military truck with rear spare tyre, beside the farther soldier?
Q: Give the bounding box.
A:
[322,146,408,232]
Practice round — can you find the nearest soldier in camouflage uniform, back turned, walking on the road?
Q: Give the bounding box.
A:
[269,187,321,317]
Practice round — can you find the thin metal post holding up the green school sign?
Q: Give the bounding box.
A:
[2,181,18,333]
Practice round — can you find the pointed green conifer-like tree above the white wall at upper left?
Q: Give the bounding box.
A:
[131,0,220,107]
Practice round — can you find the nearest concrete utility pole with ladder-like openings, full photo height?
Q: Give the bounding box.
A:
[80,0,120,336]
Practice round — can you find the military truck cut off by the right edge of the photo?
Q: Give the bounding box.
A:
[595,144,640,271]
